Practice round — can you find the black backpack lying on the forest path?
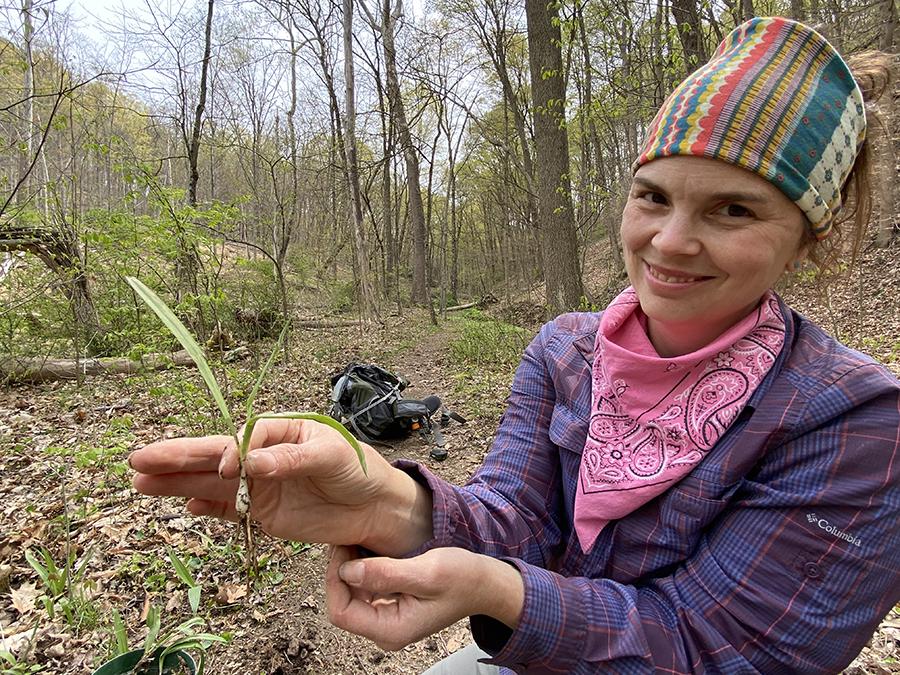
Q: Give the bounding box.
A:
[329,363,465,461]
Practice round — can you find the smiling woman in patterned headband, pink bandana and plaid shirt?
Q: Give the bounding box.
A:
[131,18,900,673]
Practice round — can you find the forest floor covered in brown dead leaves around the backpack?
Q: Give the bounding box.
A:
[0,240,900,675]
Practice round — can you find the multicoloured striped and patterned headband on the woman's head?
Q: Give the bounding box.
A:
[633,17,866,239]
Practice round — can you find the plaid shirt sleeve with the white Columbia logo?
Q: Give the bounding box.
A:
[472,366,900,675]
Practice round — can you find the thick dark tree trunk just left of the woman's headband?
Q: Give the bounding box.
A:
[525,0,583,316]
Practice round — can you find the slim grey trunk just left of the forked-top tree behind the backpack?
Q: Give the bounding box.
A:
[343,0,378,319]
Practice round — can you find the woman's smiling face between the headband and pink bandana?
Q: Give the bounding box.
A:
[622,156,807,356]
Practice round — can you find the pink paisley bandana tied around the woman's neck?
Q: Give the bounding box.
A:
[575,288,785,553]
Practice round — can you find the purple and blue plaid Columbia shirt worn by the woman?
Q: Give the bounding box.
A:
[399,308,900,675]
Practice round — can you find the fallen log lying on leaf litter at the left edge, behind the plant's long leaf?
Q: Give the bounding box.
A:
[0,350,202,383]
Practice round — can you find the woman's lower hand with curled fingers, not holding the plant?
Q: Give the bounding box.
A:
[325,546,525,650]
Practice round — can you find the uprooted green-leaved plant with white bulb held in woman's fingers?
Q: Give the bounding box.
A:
[125,277,367,585]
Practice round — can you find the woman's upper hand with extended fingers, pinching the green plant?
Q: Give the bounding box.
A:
[129,420,431,555]
